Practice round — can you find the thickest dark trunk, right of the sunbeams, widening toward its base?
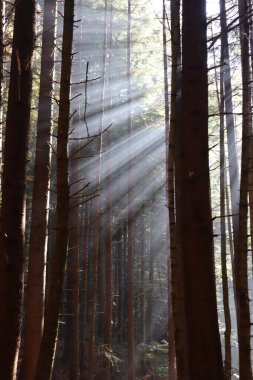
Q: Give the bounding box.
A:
[176,0,224,380]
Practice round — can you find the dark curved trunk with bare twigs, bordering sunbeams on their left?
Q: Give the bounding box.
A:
[35,0,74,380]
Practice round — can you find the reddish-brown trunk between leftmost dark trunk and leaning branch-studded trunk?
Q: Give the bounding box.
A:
[24,0,56,380]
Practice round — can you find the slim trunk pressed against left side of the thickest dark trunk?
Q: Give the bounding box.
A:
[167,0,185,379]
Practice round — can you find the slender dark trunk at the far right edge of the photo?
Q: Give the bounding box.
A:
[234,0,252,380]
